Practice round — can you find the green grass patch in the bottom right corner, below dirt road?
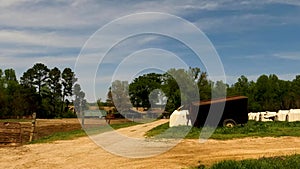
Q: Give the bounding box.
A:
[191,154,300,169]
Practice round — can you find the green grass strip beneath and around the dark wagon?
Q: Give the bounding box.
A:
[146,121,300,140]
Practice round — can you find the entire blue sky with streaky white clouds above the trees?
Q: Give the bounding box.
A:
[0,0,300,102]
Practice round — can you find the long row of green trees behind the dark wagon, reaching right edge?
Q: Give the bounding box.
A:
[107,68,300,112]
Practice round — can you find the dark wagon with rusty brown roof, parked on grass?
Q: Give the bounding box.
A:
[189,96,248,127]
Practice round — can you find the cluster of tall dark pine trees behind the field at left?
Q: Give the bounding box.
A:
[0,63,86,118]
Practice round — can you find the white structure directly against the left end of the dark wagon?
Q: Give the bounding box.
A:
[169,110,192,127]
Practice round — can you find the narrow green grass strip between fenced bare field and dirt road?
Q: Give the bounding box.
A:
[29,122,140,144]
